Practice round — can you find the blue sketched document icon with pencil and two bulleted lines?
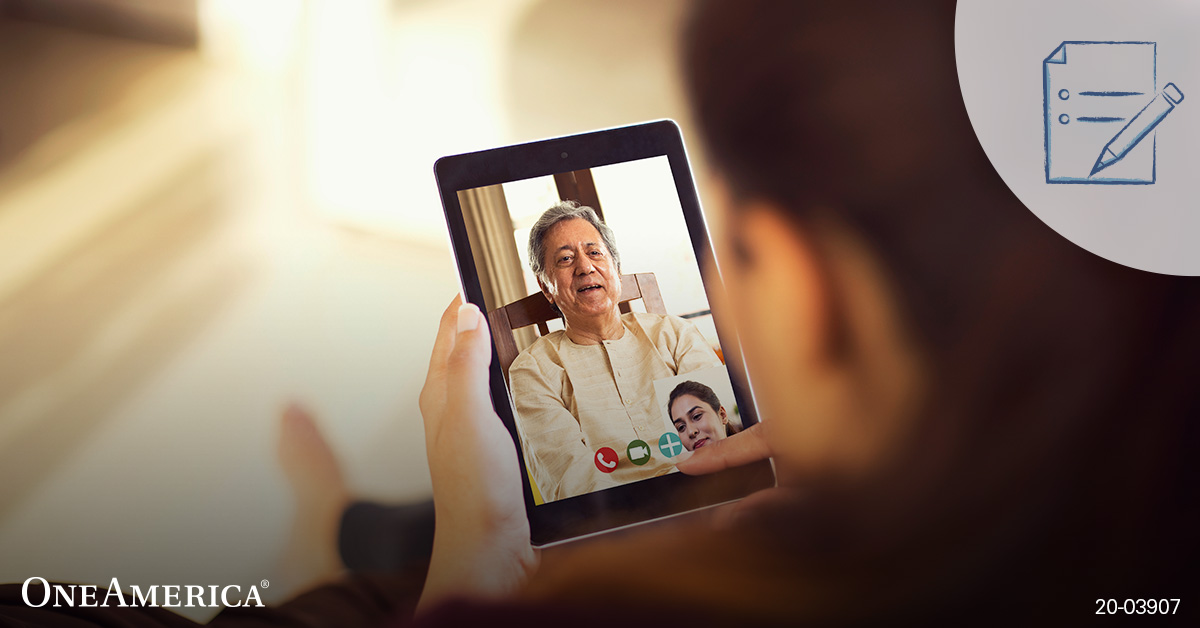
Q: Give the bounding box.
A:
[1042,41,1183,185]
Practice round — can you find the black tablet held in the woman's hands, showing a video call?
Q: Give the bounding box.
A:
[434,120,775,546]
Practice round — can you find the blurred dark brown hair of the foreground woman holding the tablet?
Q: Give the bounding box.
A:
[685,0,1200,614]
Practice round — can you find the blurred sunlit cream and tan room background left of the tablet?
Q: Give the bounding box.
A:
[0,0,703,619]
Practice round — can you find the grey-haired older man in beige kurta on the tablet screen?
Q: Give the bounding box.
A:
[509,202,721,501]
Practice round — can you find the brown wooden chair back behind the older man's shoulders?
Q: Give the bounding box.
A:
[487,273,667,381]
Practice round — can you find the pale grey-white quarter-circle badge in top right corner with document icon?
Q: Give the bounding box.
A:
[955,0,1200,275]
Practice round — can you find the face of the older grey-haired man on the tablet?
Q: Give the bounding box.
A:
[542,219,620,325]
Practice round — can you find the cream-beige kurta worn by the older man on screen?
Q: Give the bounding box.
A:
[509,312,721,502]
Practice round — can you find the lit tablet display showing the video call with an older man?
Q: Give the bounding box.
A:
[458,156,743,504]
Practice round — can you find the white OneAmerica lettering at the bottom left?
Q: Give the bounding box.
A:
[20,576,268,609]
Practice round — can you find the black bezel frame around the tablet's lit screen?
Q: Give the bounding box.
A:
[433,120,775,546]
